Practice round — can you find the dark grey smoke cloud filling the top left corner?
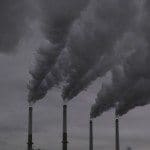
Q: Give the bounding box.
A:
[0,0,33,53]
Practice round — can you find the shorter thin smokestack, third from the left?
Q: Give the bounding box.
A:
[89,119,93,150]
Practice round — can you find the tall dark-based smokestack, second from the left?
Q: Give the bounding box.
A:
[62,104,68,150]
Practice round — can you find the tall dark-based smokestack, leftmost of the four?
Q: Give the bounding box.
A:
[27,103,33,150]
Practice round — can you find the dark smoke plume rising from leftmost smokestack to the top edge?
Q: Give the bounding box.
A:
[28,0,88,101]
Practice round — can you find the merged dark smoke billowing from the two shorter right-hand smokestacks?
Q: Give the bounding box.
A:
[91,1,150,117]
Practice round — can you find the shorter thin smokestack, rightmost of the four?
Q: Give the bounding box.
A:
[115,108,120,150]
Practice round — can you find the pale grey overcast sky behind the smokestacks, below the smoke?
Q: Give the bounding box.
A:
[0,0,150,150]
